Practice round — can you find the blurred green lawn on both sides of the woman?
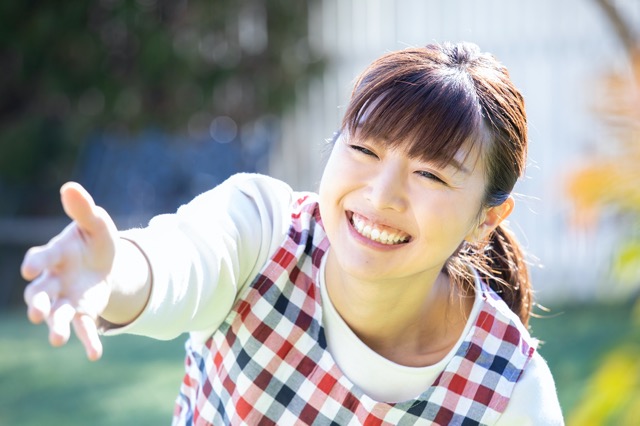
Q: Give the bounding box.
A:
[0,304,638,426]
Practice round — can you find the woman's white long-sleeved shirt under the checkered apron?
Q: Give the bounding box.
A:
[106,174,563,426]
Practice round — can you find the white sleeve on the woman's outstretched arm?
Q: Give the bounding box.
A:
[105,174,292,341]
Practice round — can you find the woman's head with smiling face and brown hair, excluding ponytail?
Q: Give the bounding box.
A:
[320,44,527,296]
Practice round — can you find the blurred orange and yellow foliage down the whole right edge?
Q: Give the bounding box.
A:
[568,0,640,426]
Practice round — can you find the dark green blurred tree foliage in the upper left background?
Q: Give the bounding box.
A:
[0,0,322,215]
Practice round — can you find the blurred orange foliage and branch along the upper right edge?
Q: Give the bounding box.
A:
[568,0,640,292]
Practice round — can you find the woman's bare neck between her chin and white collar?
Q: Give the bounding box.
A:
[325,252,473,367]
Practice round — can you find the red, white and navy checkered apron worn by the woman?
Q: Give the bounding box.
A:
[174,195,535,426]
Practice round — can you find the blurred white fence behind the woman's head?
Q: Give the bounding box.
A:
[269,0,640,301]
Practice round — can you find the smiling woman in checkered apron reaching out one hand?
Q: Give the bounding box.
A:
[22,43,563,425]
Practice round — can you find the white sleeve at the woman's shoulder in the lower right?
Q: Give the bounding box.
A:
[496,351,564,426]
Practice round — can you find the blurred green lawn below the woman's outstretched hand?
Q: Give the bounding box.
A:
[0,311,184,426]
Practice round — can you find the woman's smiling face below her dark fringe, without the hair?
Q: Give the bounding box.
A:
[319,132,496,281]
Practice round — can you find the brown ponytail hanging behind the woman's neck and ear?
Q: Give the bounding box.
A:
[479,225,533,326]
